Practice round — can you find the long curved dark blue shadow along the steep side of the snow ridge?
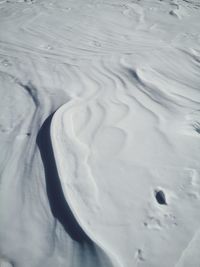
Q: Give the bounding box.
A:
[37,115,91,243]
